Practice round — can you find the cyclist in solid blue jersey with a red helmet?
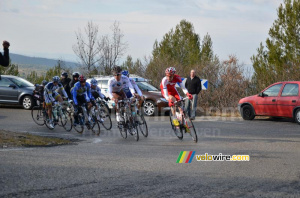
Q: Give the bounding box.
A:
[72,75,94,125]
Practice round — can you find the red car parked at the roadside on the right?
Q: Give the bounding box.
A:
[238,81,300,124]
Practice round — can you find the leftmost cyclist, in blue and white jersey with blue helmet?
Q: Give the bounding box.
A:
[44,76,68,128]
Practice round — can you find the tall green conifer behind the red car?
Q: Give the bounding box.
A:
[251,0,300,90]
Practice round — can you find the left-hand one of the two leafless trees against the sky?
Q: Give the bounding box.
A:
[73,21,101,76]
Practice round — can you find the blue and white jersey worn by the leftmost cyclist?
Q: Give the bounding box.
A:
[44,82,68,104]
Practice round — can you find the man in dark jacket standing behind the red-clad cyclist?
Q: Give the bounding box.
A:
[185,70,202,120]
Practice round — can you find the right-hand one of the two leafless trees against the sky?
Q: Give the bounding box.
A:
[98,21,128,75]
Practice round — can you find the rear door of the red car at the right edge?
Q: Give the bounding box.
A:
[277,83,299,117]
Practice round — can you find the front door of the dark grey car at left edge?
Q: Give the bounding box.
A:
[0,76,19,103]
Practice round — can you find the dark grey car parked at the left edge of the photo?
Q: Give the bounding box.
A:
[0,75,35,109]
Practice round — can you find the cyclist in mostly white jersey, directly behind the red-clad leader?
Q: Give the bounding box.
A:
[108,66,136,123]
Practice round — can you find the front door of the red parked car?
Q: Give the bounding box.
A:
[255,83,282,116]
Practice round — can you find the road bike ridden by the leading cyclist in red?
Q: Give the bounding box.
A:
[170,98,198,143]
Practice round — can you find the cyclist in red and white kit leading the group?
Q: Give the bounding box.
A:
[160,67,193,126]
